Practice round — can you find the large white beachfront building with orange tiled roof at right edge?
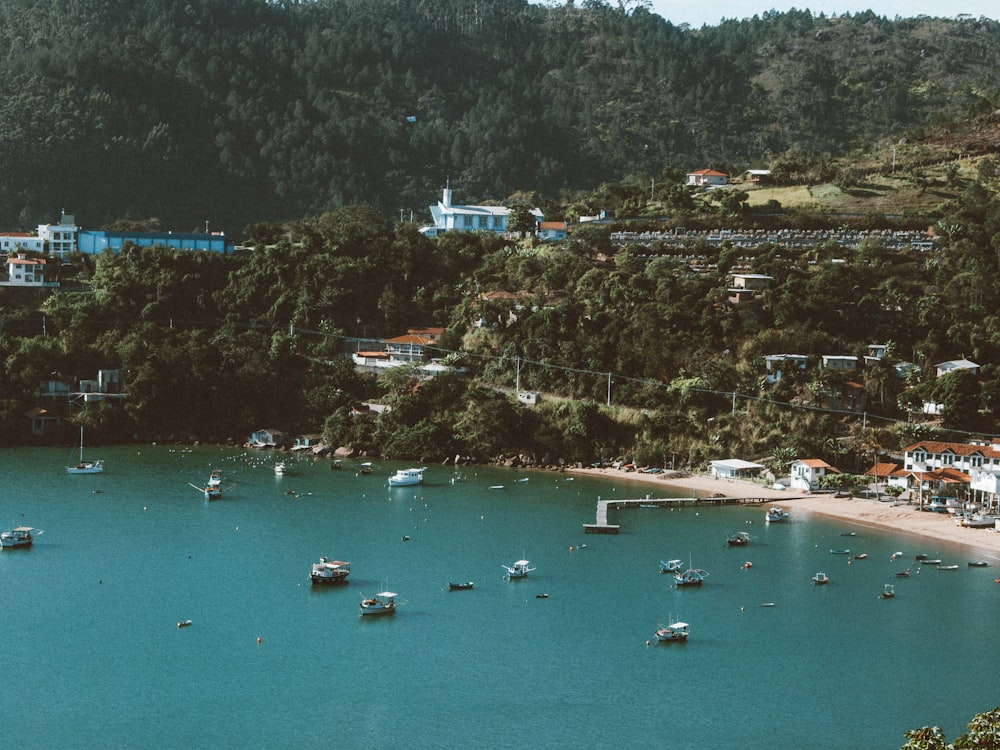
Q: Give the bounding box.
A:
[903,440,1000,510]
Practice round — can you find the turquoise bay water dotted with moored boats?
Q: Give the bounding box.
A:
[0,446,1000,750]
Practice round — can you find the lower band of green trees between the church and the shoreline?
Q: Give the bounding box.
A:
[0,162,1000,472]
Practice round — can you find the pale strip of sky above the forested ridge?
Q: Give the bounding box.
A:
[636,0,1000,28]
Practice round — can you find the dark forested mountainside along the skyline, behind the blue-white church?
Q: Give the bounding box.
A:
[0,0,1000,237]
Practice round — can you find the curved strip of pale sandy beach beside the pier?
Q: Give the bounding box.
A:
[566,468,1000,565]
